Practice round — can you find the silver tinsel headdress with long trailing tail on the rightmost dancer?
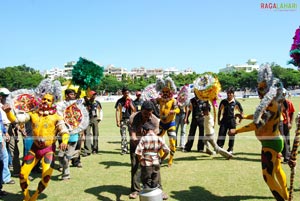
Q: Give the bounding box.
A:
[253,64,283,124]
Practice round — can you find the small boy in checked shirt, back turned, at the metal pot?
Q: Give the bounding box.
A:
[135,121,170,195]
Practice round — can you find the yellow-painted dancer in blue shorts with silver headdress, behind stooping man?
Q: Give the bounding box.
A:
[155,77,180,166]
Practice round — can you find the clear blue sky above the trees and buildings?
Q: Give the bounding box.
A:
[0,0,300,73]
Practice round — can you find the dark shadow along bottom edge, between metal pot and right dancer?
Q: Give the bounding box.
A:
[170,186,273,201]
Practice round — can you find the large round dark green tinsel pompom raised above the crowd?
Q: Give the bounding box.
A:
[72,57,104,90]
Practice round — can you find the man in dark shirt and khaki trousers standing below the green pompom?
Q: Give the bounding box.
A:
[83,91,103,156]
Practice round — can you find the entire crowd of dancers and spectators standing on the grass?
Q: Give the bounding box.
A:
[0,68,295,200]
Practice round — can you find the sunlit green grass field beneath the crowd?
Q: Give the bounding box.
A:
[3,98,300,201]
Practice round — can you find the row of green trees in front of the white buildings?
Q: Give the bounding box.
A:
[0,63,300,93]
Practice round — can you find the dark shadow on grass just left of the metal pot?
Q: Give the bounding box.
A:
[84,185,130,201]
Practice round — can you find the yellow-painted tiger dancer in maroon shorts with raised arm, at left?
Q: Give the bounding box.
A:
[3,81,69,201]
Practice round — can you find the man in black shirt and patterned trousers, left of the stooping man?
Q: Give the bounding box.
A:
[115,87,135,155]
